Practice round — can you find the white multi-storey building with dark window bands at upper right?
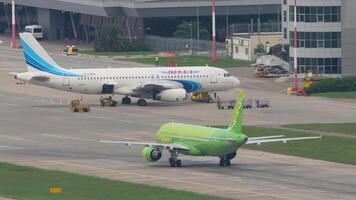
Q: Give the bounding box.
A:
[281,0,356,76]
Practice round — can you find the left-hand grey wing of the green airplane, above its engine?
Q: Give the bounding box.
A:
[100,140,189,151]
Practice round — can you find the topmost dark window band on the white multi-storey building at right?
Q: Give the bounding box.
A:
[289,6,341,23]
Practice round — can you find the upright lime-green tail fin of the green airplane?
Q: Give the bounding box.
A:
[228,91,245,133]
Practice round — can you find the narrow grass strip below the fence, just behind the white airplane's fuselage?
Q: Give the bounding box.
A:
[132,56,251,68]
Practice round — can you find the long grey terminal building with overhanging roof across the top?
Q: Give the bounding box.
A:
[0,0,280,40]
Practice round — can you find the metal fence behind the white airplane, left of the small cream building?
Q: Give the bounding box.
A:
[145,35,228,56]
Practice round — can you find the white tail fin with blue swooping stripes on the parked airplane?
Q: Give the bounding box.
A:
[20,33,80,77]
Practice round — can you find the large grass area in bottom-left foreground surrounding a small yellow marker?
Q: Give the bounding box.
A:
[0,163,229,200]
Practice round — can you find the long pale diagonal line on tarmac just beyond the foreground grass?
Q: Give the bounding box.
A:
[47,161,297,200]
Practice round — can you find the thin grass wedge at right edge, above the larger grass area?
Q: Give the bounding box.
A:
[283,123,356,135]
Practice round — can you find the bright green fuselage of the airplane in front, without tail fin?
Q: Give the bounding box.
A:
[156,123,247,157]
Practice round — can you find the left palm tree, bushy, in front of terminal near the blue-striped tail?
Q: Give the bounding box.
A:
[95,24,125,51]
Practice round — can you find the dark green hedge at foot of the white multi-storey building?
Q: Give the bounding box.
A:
[305,76,356,94]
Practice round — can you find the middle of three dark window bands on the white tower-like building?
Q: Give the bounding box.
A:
[289,31,341,48]
